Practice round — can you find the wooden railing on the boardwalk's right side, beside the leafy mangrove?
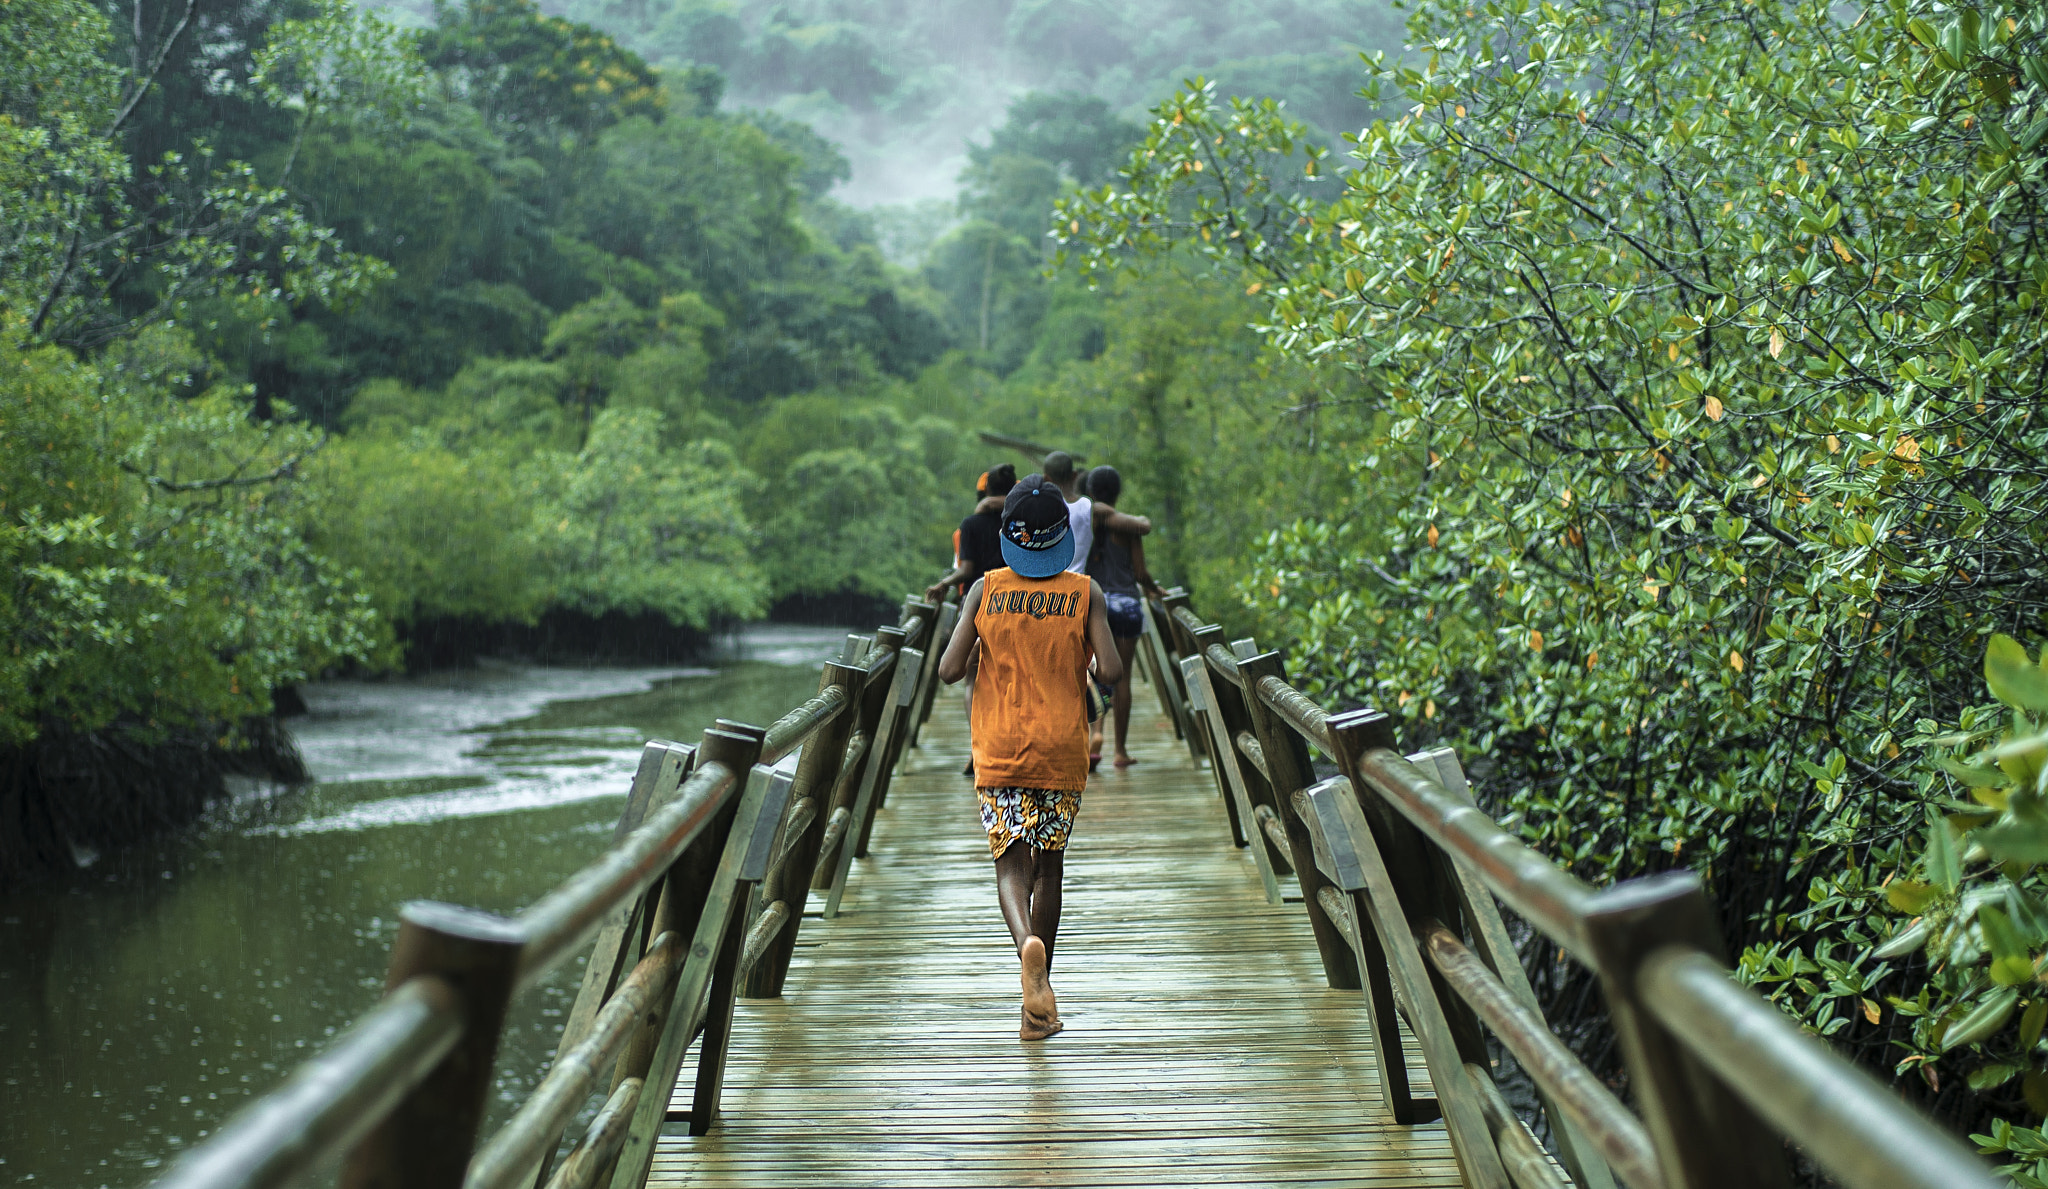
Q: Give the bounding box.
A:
[1143,591,1999,1189]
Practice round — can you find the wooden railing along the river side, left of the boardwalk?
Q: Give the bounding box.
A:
[158,600,958,1189]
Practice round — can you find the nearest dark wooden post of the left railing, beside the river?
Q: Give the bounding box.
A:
[340,900,522,1189]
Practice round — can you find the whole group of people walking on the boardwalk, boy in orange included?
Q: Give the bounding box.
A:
[928,450,1155,1040]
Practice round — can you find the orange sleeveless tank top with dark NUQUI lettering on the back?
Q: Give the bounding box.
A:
[975,567,1090,792]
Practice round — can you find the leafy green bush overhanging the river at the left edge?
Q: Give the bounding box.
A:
[0,334,371,745]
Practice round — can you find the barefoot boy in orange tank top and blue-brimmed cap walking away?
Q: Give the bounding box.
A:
[938,475,1122,1040]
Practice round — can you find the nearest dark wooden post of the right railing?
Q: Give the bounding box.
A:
[1585,872,1792,1189]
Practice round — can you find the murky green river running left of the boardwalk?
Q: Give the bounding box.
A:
[0,626,846,1189]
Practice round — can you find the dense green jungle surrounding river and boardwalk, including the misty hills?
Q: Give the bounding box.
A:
[12,0,2048,1187]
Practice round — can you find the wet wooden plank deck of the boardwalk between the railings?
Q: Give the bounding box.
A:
[649,671,1458,1189]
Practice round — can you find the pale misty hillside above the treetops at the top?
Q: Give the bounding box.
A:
[393,0,1401,207]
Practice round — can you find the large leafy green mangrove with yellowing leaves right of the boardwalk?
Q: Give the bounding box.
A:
[1059,0,2048,1177]
